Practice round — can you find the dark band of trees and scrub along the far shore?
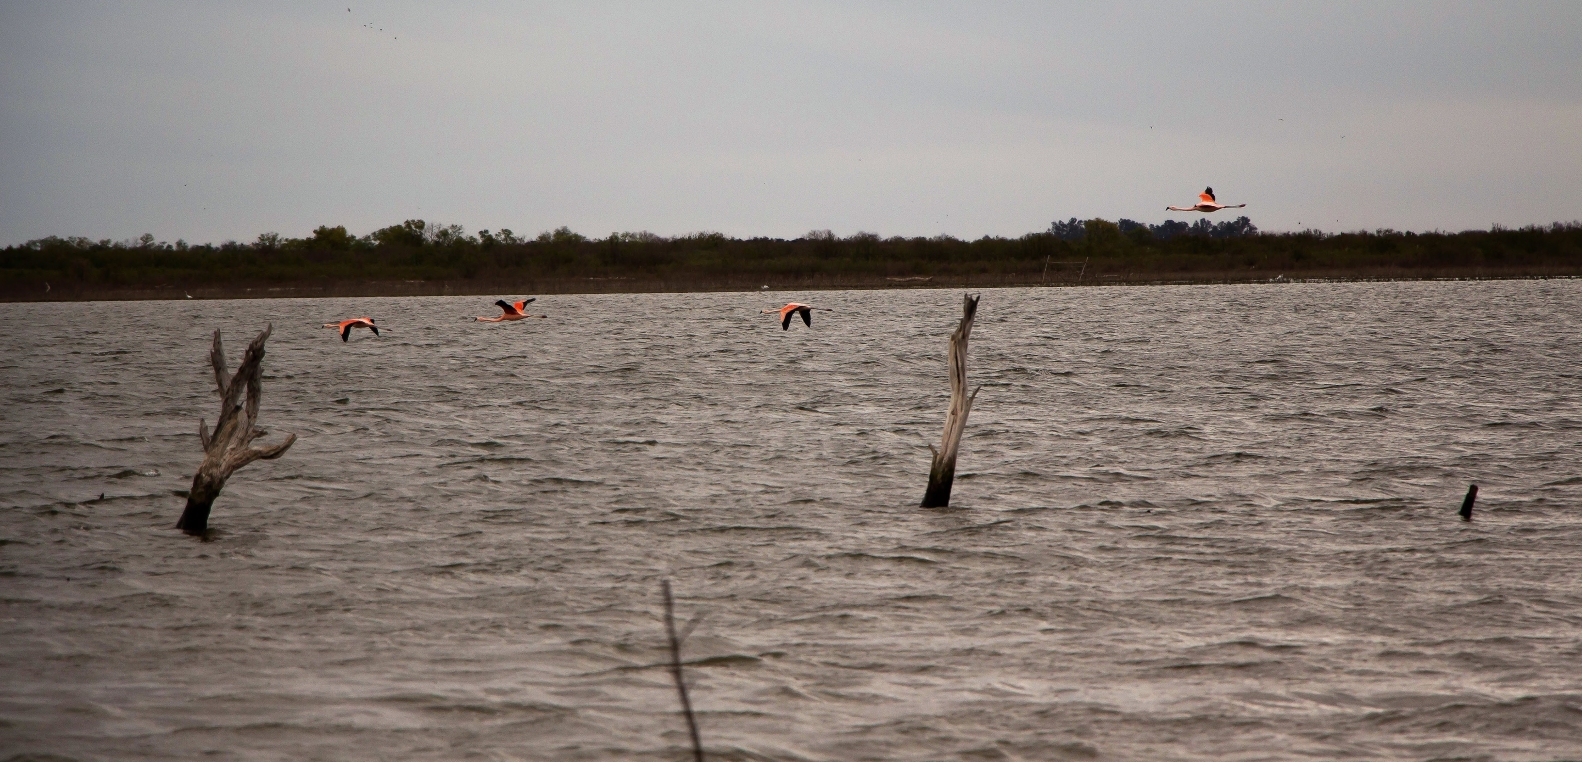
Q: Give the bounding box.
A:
[0,217,1582,300]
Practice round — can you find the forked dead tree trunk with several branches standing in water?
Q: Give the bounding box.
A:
[176,326,296,534]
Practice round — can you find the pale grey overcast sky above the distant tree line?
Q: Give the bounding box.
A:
[0,0,1582,245]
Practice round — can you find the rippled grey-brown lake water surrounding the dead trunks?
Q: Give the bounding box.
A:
[0,280,1582,760]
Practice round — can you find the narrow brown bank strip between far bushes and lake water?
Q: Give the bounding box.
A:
[0,267,1582,302]
